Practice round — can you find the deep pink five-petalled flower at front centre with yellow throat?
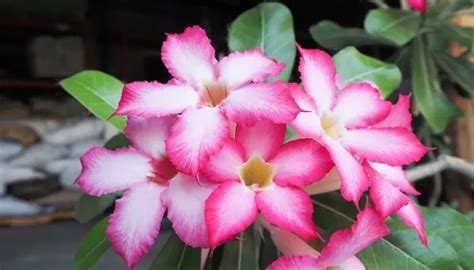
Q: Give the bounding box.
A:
[201,121,333,248]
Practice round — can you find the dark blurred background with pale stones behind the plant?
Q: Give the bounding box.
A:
[0,0,474,270]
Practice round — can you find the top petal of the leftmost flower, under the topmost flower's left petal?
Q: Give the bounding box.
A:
[125,116,176,159]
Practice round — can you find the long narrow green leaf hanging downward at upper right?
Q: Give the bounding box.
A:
[411,37,462,133]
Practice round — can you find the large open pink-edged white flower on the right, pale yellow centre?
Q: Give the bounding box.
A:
[291,46,427,205]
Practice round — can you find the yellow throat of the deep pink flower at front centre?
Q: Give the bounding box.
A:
[240,157,274,190]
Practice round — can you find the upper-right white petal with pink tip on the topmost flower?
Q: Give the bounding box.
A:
[218,48,285,89]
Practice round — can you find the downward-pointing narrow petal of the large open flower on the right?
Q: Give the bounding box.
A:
[324,137,369,205]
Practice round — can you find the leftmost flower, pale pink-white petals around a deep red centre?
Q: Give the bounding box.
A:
[77,116,215,269]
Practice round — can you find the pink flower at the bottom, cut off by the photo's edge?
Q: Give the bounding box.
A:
[267,204,389,270]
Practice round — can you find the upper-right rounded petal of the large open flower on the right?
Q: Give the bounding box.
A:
[333,83,392,128]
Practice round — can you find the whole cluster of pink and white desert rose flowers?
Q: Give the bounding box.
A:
[77,26,427,269]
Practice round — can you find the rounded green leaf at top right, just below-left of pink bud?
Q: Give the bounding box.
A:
[364,9,421,46]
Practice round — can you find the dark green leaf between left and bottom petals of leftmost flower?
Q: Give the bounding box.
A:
[74,194,120,223]
